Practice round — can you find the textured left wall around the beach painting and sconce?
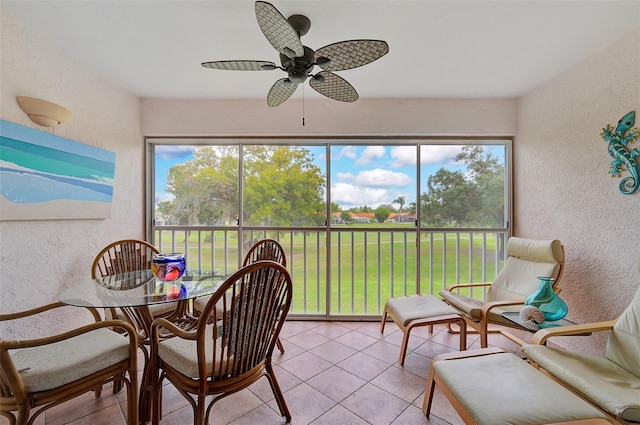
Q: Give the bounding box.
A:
[0,12,144,338]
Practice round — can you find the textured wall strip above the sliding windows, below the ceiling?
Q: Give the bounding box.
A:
[142,97,516,136]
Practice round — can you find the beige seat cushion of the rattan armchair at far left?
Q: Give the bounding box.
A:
[10,329,129,392]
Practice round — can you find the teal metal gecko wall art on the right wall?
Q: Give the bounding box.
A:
[600,111,640,195]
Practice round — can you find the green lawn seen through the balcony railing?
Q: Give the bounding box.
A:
[155,226,502,316]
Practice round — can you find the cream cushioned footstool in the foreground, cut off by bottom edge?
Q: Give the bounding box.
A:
[422,348,611,425]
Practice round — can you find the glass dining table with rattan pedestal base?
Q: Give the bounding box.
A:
[58,270,225,424]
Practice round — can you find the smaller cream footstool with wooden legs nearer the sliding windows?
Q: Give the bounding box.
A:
[380,294,467,365]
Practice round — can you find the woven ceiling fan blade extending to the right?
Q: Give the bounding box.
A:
[316,40,389,71]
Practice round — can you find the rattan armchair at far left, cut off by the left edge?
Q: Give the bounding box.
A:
[0,302,138,425]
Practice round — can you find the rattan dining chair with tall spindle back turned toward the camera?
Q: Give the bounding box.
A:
[151,261,292,425]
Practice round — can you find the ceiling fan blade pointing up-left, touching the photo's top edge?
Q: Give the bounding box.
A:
[256,1,304,58]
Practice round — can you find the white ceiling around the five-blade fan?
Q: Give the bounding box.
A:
[0,0,640,102]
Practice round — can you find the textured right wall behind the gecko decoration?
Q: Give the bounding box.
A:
[514,25,640,353]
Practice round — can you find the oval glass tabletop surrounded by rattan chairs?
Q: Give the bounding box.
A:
[58,270,225,307]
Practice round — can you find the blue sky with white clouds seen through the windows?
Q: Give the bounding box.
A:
[156,142,504,210]
